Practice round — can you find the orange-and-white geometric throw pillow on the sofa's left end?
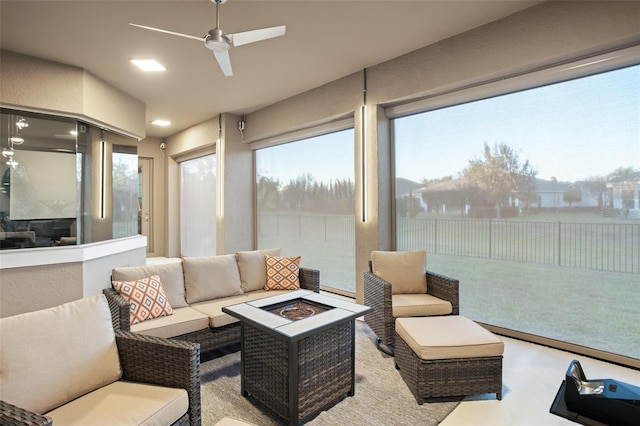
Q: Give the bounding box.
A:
[113,275,173,324]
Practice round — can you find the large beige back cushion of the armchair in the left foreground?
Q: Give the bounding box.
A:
[0,294,122,414]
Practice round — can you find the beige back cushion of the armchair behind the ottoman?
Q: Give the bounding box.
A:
[371,250,427,294]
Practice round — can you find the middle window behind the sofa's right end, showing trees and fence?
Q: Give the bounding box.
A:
[256,129,355,293]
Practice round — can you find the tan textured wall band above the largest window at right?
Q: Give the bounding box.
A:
[367,1,640,104]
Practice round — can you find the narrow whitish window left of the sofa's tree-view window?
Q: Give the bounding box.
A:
[180,154,216,257]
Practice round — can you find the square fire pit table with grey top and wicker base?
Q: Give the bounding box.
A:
[222,290,372,425]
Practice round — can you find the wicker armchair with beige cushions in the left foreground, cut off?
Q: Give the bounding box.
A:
[0,294,201,426]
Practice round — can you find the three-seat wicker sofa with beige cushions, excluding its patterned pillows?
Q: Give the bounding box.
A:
[103,249,320,352]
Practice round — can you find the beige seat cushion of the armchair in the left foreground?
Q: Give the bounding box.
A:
[46,381,189,426]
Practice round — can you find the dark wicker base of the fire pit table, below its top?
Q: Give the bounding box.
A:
[241,320,355,424]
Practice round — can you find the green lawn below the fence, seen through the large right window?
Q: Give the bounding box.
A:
[427,255,640,359]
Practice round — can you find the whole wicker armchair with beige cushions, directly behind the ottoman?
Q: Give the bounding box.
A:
[364,251,460,355]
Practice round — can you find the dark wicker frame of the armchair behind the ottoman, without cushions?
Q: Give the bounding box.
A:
[364,255,460,355]
